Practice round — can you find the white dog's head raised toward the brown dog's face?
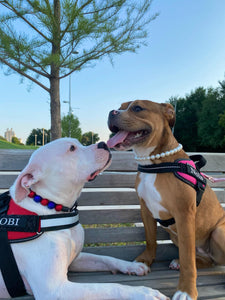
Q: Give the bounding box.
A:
[10,138,111,211]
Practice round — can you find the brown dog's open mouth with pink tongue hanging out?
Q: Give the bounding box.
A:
[107,129,150,150]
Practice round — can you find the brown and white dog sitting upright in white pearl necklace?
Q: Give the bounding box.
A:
[107,100,225,300]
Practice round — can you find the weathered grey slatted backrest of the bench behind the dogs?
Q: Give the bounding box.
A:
[0,149,225,260]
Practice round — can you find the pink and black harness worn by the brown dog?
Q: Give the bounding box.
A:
[138,155,206,227]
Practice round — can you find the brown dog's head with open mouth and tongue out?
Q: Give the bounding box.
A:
[107,100,175,150]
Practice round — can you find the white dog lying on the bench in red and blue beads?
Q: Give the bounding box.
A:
[0,138,167,300]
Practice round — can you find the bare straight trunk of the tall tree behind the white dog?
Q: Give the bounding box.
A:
[50,0,61,140]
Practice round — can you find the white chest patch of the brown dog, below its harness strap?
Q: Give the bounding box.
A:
[137,173,167,219]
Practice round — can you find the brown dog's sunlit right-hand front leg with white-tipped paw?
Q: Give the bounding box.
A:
[173,203,198,300]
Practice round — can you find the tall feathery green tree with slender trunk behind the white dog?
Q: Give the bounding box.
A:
[0,0,157,139]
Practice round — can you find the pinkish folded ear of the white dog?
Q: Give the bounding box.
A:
[14,165,41,202]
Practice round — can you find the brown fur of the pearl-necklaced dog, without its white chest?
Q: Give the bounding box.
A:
[107,100,225,299]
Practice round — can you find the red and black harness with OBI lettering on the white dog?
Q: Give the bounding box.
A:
[0,192,79,297]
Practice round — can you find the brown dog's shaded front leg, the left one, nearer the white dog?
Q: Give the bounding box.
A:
[136,199,157,266]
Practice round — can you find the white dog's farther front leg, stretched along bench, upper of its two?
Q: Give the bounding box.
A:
[69,252,149,275]
